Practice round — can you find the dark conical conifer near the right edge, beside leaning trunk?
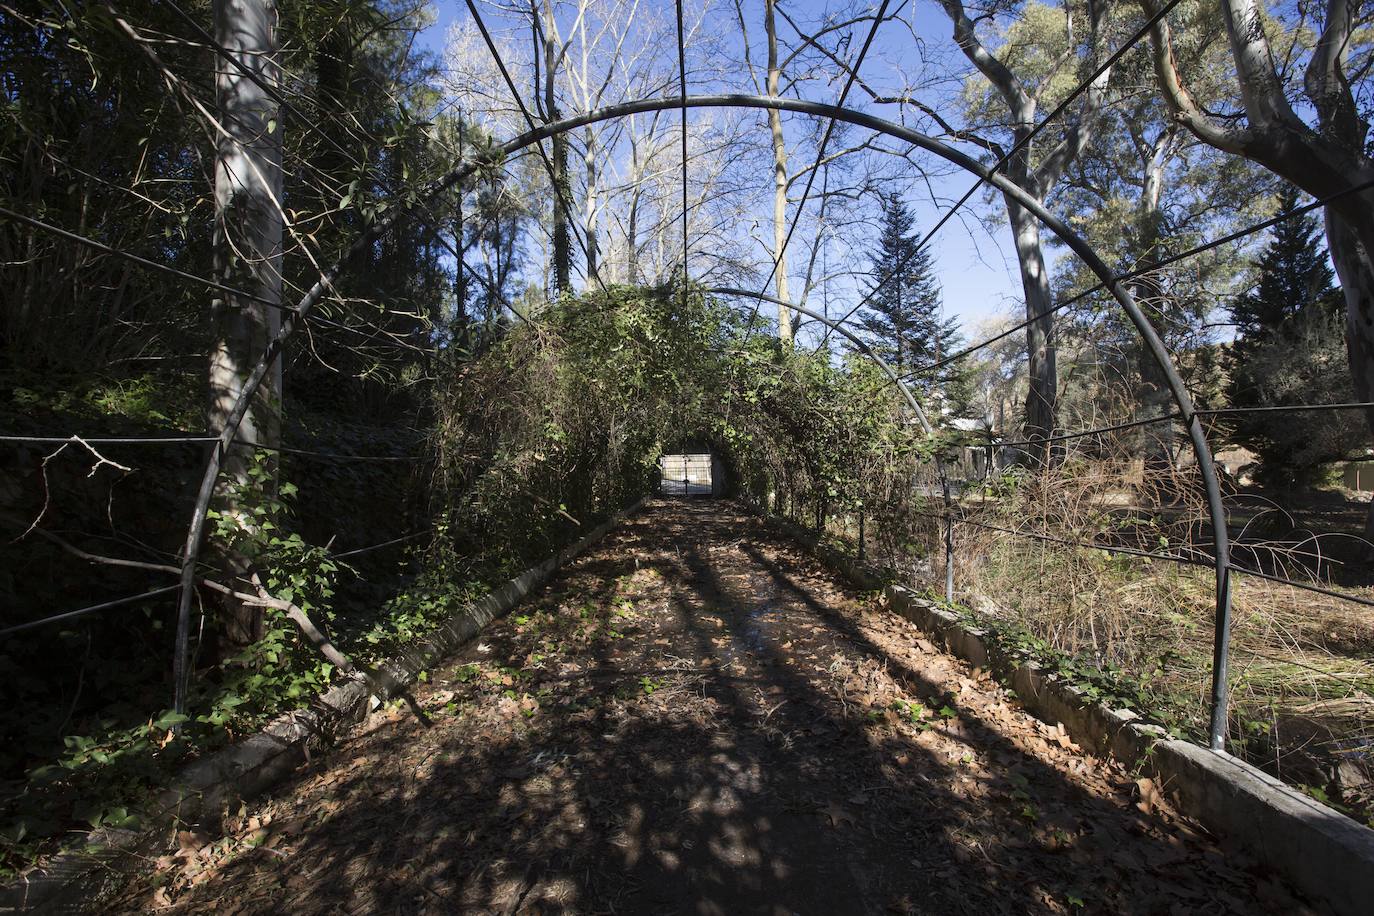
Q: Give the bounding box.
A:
[1227,185,1364,488]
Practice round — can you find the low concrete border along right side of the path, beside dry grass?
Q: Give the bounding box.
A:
[765,516,1374,916]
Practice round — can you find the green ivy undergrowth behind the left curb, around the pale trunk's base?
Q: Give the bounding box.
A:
[0,470,493,879]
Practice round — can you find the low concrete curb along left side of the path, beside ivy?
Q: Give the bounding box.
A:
[0,497,647,912]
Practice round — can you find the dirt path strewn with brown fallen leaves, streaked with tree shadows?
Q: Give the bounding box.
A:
[124,503,1303,916]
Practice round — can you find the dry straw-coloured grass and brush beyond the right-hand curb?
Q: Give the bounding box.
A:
[802,456,1374,820]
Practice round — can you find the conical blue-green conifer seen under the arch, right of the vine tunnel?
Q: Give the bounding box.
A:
[859,195,967,411]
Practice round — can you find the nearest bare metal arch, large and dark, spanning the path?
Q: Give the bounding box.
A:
[177,95,1231,750]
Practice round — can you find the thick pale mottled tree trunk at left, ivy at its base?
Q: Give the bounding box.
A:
[209,0,282,652]
